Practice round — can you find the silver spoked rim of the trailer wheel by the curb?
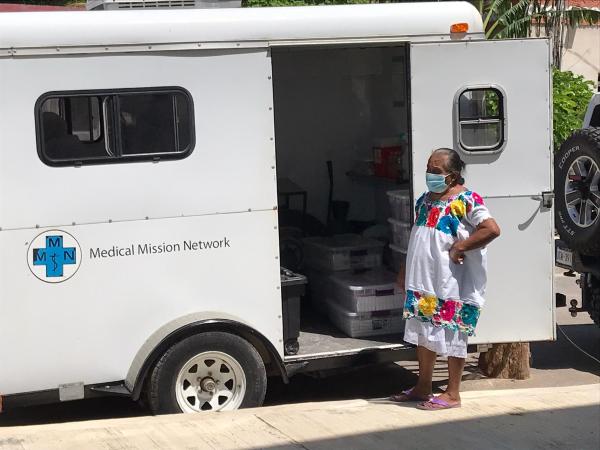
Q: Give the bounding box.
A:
[175,351,246,413]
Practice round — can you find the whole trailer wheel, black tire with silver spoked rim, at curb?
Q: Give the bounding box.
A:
[149,332,267,414]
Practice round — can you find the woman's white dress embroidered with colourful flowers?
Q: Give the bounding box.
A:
[404,191,491,358]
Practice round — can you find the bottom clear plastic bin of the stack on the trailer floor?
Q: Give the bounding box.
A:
[327,299,404,337]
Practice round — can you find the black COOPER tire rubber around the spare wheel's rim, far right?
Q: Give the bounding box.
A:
[554,128,600,255]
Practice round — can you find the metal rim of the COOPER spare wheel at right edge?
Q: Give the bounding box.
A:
[565,156,600,228]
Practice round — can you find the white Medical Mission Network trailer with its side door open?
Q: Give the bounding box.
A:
[0,2,554,412]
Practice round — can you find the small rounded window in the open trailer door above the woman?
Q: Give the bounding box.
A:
[458,88,505,152]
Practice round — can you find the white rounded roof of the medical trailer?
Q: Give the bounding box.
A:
[0,2,483,55]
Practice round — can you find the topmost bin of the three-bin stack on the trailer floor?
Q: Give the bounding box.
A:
[303,234,384,272]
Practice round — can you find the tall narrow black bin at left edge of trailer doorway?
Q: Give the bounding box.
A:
[280,267,307,355]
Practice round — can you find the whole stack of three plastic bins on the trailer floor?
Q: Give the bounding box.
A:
[304,234,404,337]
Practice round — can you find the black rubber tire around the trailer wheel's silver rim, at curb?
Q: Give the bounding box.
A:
[148,332,267,414]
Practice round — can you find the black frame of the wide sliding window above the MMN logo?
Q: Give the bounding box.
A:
[34,86,196,167]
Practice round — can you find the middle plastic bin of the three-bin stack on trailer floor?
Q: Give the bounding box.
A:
[330,269,404,313]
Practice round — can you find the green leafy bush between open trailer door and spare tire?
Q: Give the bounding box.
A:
[552,69,594,150]
